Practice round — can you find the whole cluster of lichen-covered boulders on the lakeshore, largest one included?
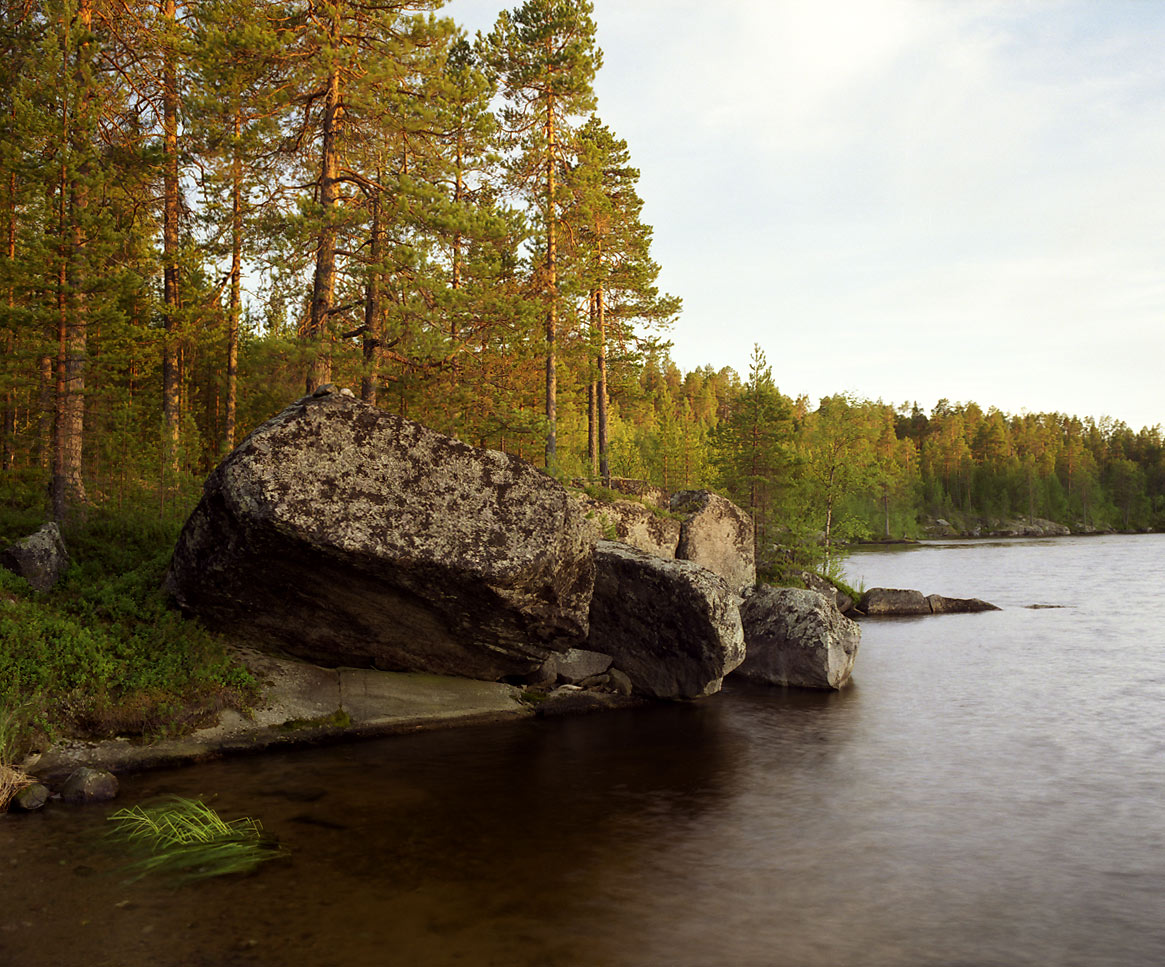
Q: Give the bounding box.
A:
[167,386,859,699]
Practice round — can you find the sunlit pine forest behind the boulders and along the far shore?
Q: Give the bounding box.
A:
[0,0,1165,579]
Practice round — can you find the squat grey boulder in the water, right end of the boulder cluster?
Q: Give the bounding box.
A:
[733,586,862,689]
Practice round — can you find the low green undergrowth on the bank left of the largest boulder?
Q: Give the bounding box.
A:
[0,480,257,758]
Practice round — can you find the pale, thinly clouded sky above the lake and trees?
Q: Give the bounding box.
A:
[443,0,1165,430]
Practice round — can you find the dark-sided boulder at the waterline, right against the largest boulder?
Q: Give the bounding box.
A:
[588,541,744,699]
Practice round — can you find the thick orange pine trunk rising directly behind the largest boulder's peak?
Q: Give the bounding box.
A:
[308,47,340,393]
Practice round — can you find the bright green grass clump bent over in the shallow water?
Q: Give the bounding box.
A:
[110,796,287,883]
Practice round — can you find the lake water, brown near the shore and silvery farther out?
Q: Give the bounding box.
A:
[0,536,1165,967]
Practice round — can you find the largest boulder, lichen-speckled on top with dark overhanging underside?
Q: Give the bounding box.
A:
[167,387,594,679]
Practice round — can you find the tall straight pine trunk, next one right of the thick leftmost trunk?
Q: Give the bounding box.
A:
[162,0,182,473]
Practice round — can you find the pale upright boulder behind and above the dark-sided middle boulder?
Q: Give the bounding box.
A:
[671,490,756,592]
